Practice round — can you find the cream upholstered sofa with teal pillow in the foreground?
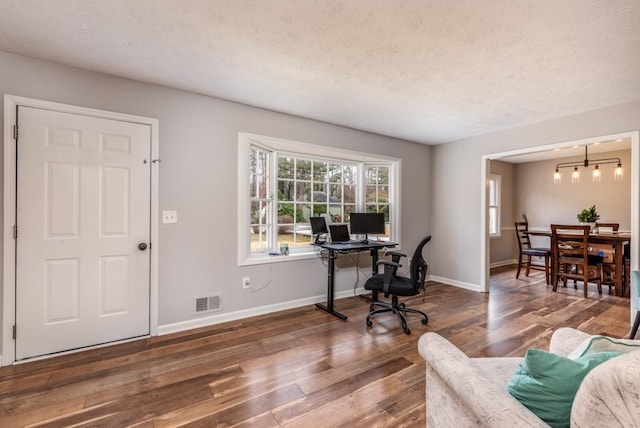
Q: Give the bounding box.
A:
[418,328,640,428]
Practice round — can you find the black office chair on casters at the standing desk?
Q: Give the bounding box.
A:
[364,235,431,334]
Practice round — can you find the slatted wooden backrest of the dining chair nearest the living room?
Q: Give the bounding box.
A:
[551,224,591,264]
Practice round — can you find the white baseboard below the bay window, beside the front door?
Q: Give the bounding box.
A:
[158,287,367,336]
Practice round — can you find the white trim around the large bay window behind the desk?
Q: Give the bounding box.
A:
[238,132,402,266]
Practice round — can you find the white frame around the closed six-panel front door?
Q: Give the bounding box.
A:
[0,94,159,366]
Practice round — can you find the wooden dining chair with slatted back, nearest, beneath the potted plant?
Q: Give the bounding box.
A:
[551,224,602,297]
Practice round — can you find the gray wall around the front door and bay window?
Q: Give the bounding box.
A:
[0,51,432,332]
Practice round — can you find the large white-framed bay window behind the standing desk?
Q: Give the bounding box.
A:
[238,133,400,265]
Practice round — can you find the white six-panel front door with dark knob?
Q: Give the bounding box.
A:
[15,106,151,360]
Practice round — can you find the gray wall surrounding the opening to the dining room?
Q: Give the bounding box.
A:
[431,101,640,287]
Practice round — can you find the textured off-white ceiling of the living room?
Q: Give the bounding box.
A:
[0,0,640,144]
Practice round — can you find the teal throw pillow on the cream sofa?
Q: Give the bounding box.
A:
[507,349,620,427]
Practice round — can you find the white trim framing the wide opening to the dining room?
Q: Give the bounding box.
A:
[480,131,640,296]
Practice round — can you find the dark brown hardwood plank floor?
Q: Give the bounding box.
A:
[0,268,629,428]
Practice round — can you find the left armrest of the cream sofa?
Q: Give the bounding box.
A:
[418,333,548,428]
